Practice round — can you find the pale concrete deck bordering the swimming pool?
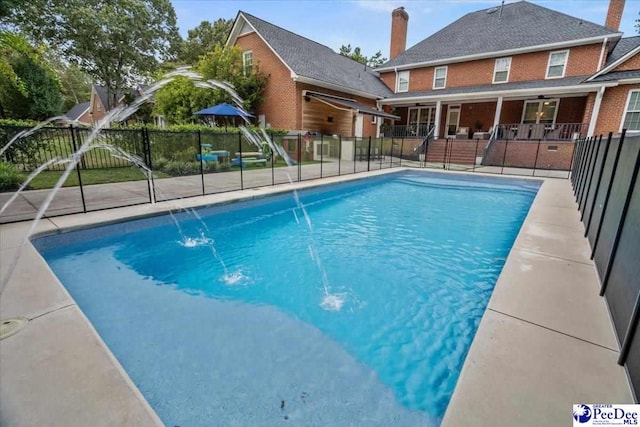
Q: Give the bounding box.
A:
[0,169,633,426]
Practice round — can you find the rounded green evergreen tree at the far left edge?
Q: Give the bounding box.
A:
[0,31,62,120]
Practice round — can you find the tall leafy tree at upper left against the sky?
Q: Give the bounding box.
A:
[9,0,180,108]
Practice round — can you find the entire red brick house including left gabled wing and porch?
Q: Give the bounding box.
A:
[227,0,640,140]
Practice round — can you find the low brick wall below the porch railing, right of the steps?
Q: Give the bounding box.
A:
[483,141,575,170]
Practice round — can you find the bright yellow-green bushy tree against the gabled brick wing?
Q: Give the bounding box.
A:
[154,46,267,123]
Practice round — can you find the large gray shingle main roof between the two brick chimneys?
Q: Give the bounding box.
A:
[382,1,616,68]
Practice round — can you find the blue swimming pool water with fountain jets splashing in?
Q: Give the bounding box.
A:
[34,172,539,426]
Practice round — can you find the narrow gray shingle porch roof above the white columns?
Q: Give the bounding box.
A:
[388,76,589,99]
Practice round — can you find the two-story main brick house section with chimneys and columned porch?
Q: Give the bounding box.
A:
[377,0,640,140]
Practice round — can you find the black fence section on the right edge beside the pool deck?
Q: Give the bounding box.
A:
[571,131,640,402]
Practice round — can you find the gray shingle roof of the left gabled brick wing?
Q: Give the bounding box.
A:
[240,11,391,97]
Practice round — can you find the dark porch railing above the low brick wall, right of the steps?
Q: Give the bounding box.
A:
[494,123,588,141]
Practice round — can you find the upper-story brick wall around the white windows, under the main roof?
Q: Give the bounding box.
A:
[382,43,602,92]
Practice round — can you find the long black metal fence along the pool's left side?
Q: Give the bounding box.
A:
[0,126,402,223]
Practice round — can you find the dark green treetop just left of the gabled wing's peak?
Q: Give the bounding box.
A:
[179,18,233,65]
